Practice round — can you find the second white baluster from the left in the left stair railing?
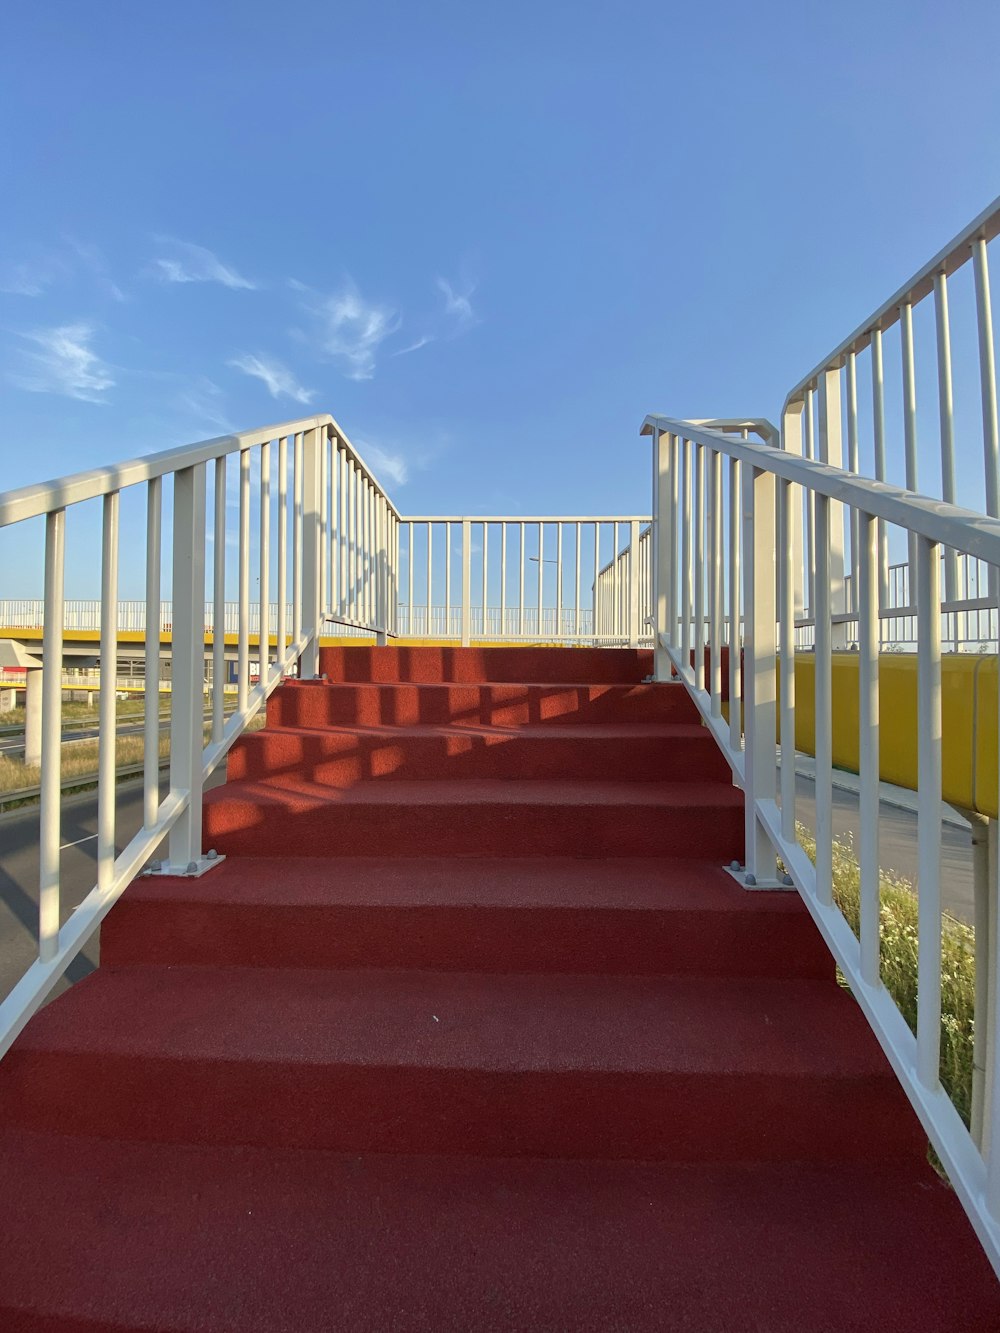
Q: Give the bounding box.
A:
[97,491,120,892]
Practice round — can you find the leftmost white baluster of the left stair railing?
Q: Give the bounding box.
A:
[39,509,65,962]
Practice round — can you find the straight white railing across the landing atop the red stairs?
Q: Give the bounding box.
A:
[397,515,649,647]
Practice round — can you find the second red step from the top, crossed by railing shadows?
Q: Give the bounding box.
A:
[267,681,699,726]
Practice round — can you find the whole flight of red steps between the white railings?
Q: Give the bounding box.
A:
[0,648,1000,1333]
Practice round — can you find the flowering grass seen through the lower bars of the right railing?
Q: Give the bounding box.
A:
[796,825,976,1125]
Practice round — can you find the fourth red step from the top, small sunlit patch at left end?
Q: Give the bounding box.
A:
[204,773,743,864]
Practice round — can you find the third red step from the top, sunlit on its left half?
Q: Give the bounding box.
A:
[227,722,731,786]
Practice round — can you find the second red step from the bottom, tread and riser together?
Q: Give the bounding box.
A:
[0,966,925,1162]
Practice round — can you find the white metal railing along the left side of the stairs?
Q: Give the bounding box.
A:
[0,416,399,1054]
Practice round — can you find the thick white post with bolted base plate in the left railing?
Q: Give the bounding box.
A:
[160,464,214,874]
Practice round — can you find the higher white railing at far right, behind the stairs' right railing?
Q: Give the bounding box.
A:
[781,199,1000,629]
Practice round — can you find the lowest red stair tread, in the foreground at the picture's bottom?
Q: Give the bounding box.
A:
[0,1130,1000,1333]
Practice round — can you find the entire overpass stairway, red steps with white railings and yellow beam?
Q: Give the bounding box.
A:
[0,201,1000,1330]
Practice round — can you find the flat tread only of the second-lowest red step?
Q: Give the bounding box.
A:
[7,966,892,1082]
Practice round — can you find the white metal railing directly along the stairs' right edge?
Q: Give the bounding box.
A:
[643,416,1000,1272]
